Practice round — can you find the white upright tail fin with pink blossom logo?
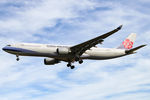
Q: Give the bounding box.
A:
[118,33,136,49]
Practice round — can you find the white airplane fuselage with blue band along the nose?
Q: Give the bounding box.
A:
[3,43,126,61]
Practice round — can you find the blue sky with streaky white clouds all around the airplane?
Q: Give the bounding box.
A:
[0,0,150,100]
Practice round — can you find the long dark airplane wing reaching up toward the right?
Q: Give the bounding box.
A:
[70,25,122,56]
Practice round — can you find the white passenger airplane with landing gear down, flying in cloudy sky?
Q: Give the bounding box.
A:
[2,25,146,69]
